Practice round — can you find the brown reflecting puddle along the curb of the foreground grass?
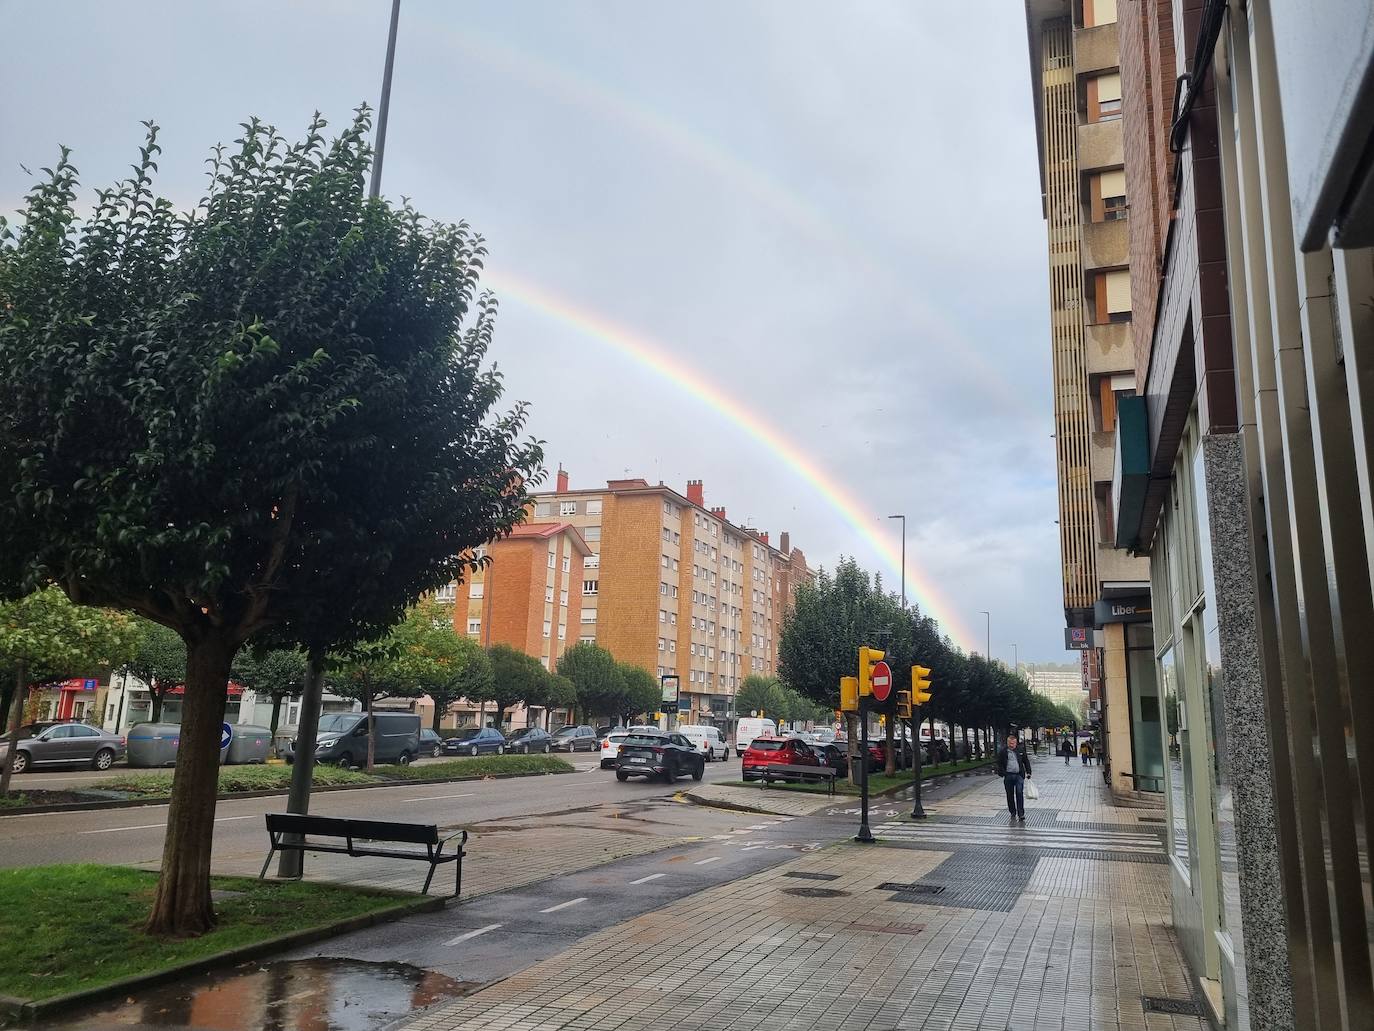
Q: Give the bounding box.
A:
[44,958,481,1031]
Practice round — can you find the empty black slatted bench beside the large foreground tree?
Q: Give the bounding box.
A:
[258,812,467,899]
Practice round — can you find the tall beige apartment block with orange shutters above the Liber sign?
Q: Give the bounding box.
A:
[1026,0,1164,800]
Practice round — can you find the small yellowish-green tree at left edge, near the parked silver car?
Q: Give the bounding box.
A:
[0,587,139,799]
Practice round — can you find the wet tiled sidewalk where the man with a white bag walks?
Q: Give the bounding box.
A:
[405,762,1205,1031]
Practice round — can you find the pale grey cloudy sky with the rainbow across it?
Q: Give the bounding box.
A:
[0,0,1065,661]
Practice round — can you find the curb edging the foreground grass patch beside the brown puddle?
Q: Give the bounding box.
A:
[0,888,439,1024]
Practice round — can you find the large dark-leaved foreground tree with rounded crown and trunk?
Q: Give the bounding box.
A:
[0,111,541,936]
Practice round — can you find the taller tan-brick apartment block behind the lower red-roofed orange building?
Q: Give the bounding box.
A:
[516,470,809,726]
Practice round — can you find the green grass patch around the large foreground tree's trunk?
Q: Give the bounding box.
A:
[0,865,397,999]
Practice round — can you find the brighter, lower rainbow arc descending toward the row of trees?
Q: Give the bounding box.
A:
[482,271,976,649]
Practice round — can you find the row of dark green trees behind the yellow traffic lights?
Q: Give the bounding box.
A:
[780,558,1077,773]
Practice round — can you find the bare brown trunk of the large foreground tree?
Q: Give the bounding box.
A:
[144,636,236,938]
